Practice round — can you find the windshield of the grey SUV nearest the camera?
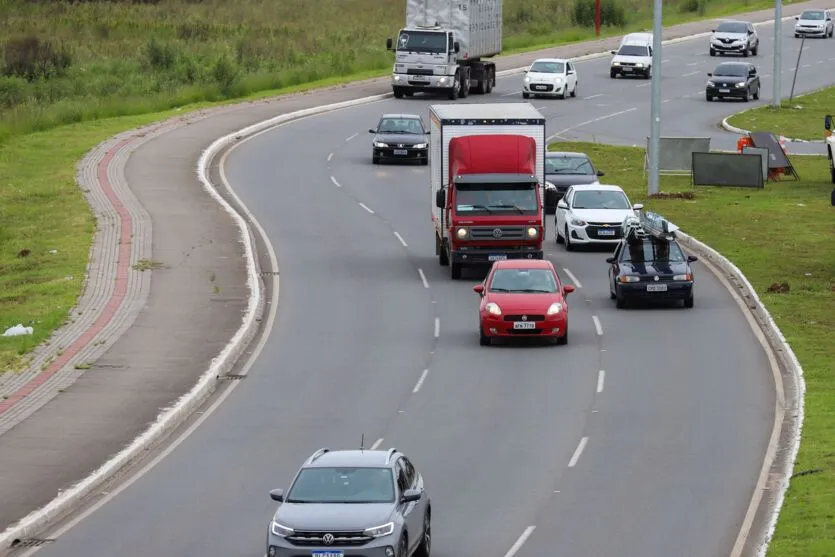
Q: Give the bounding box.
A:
[287,467,394,503]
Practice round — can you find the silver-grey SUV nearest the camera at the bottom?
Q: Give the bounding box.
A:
[267,449,432,557]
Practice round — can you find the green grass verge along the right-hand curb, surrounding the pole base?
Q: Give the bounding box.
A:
[549,142,835,557]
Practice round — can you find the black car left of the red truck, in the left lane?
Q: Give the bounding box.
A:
[368,114,429,164]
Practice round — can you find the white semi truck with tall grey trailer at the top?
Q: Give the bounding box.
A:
[386,0,502,100]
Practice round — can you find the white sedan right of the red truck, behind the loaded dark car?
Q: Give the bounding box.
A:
[554,184,644,251]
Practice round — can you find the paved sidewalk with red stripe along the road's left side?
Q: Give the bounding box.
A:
[0,0,832,528]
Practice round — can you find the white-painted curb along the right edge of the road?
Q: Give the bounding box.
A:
[676,231,806,557]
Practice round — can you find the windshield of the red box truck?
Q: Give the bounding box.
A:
[455,184,537,215]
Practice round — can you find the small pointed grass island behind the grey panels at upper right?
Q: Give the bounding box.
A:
[728,87,835,140]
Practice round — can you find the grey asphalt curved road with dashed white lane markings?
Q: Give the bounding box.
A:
[22,15,835,557]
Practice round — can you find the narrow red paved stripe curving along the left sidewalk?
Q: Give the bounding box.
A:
[0,137,134,414]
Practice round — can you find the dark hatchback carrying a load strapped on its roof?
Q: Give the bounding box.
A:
[606,232,697,309]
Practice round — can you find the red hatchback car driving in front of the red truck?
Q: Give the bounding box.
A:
[473,259,574,346]
